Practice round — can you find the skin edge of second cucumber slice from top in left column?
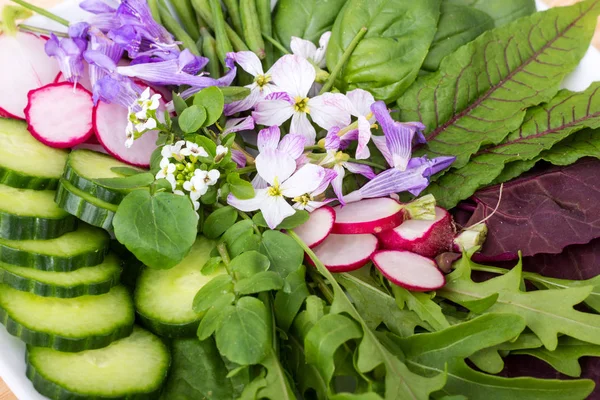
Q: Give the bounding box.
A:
[0,211,77,240]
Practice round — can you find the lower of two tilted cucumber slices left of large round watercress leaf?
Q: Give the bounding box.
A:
[55,179,118,232]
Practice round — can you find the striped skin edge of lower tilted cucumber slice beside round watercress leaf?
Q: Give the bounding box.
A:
[54,180,115,233]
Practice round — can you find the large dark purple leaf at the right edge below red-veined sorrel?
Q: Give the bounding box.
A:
[467,158,600,261]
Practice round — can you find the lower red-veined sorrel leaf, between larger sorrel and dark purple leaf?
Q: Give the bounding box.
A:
[427,83,600,208]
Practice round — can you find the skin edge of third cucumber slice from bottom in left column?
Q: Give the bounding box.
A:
[0,267,121,298]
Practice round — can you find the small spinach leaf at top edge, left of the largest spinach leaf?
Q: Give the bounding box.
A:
[273,0,346,48]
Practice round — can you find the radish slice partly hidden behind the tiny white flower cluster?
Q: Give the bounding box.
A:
[94,102,158,168]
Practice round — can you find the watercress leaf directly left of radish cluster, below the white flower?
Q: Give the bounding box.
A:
[260,231,304,279]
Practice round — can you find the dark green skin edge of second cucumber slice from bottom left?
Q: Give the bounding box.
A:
[0,306,134,353]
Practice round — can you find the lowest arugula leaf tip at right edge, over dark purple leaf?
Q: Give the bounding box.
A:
[512,336,600,378]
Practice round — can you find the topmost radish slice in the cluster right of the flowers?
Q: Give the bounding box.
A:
[332,197,405,235]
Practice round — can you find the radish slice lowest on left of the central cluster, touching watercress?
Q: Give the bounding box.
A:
[309,233,378,272]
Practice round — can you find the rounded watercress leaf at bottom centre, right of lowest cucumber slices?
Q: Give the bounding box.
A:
[216,297,271,365]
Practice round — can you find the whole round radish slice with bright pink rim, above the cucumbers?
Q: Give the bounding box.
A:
[25,82,94,149]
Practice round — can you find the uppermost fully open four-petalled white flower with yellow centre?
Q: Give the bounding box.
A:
[252,55,352,146]
